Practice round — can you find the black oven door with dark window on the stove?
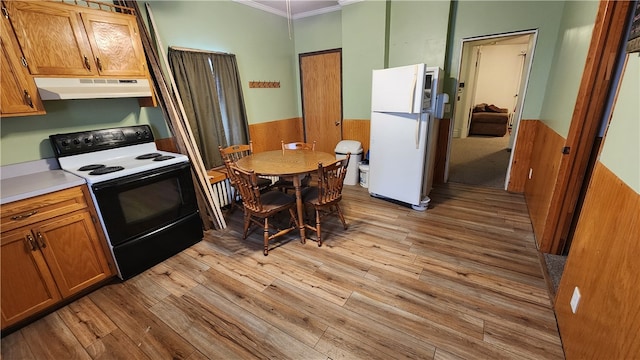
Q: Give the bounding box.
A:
[92,163,198,247]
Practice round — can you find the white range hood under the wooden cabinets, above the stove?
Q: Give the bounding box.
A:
[34,78,151,100]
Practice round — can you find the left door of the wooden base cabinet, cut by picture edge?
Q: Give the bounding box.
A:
[0,228,61,329]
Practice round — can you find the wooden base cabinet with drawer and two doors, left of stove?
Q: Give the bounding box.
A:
[0,188,115,329]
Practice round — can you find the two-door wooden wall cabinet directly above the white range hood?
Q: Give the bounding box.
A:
[4,1,147,77]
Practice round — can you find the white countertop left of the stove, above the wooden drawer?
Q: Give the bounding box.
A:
[0,159,86,205]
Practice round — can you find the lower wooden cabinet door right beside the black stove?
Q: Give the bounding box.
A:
[32,210,113,297]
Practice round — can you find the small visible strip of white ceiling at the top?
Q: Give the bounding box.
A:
[233,0,344,19]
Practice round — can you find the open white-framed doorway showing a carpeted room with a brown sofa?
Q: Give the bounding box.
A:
[445,30,537,189]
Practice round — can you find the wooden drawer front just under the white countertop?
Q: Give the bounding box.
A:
[0,186,87,232]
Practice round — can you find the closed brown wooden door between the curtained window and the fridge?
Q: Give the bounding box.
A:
[299,49,342,153]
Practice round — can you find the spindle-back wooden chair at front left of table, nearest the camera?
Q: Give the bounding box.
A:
[225,160,298,256]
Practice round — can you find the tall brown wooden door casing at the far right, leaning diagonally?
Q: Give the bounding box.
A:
[538,0,634,254]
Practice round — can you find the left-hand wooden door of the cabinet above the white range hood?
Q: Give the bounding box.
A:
[4,1,97,75]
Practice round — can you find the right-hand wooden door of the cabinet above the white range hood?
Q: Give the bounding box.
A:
[81,12,146,77]
